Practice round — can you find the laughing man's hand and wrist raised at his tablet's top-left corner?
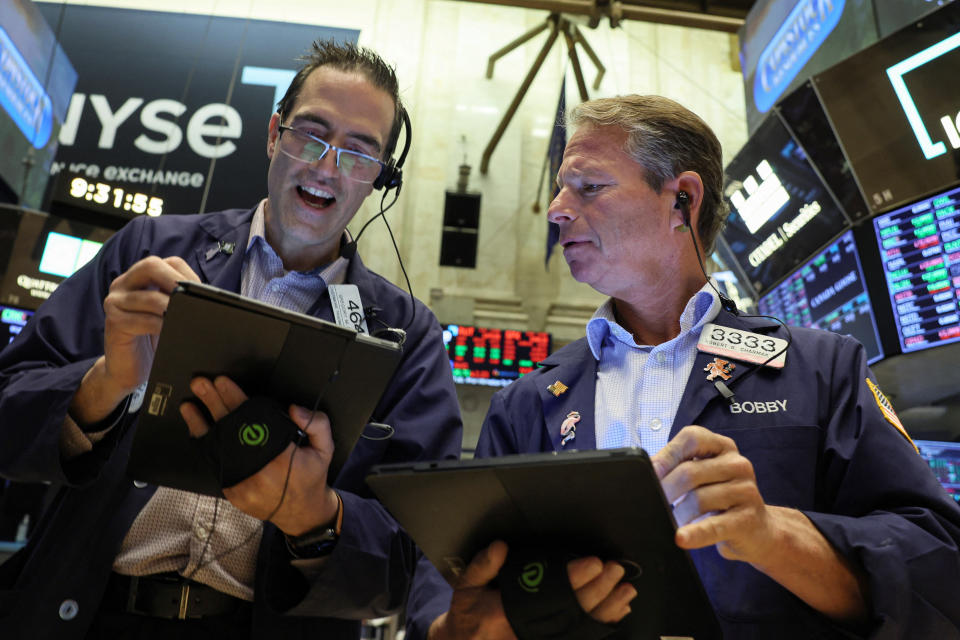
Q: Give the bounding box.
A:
[70,256,200,426]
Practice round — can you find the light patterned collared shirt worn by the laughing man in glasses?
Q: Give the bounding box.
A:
[113,200,350,601]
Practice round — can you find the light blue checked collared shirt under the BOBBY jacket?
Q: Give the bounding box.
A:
[587,284,720,455]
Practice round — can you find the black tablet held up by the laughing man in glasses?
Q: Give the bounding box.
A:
[127,282,401,496]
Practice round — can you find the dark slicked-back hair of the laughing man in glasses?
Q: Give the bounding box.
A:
[277,40,403,159]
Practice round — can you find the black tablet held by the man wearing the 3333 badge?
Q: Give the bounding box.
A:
[367,449,721,640]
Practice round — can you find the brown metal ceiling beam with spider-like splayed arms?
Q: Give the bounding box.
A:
[461,0,754,174]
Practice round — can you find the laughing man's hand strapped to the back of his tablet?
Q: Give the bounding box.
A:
[180,376,339,536]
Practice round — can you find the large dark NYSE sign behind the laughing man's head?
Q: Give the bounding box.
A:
[38,2,358,217]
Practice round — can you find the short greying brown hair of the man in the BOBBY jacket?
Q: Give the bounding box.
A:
[568,95,729,253]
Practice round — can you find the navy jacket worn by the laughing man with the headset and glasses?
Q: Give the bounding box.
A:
[0,210,462,639]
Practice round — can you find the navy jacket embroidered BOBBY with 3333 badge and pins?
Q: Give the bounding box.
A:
[477,312,960,640]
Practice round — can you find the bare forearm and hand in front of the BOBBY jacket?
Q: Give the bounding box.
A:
[651,426,870,625]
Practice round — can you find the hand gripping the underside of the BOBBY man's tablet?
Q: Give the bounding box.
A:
[428,541,637,640]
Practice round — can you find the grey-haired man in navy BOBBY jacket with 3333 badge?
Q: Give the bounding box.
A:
[436,96,960,640]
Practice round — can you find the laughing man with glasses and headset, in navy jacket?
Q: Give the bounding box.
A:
[0,42,461,638]
